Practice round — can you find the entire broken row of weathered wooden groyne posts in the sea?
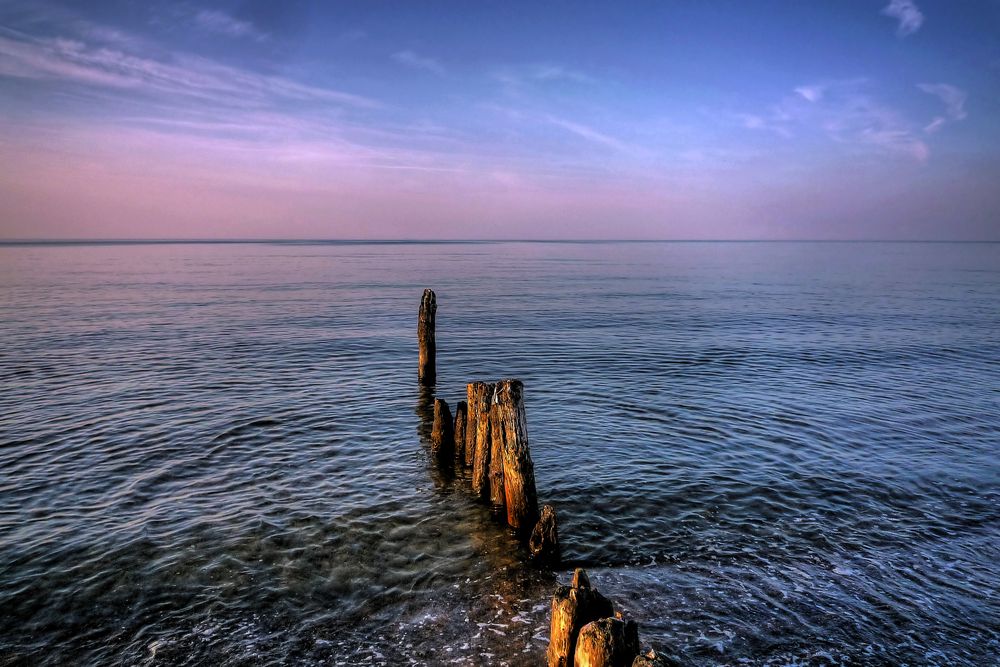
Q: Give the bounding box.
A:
[417,289,677,667]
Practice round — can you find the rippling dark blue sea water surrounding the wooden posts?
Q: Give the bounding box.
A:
[0,243,1000,665]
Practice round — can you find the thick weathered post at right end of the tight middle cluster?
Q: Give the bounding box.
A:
[496,380,538,538]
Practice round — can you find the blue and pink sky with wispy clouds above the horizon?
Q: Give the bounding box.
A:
[0,0,1000,240]
